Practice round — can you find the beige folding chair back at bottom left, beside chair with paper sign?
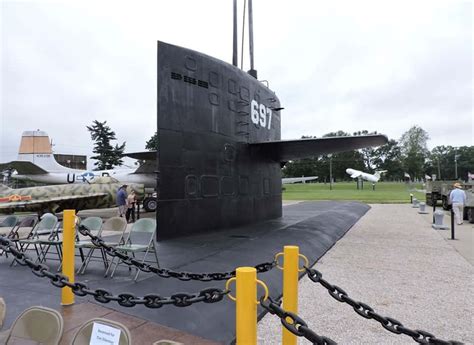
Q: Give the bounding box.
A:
[1,306,64,345]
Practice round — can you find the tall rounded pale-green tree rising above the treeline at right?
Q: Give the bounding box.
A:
[400,125,430,178]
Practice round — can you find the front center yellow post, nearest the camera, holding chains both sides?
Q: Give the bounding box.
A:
[235,267,257,345]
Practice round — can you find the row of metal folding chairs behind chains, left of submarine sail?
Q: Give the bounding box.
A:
[0,213,159,281]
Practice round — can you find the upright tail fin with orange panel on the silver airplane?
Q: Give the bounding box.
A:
[18,130,71,172]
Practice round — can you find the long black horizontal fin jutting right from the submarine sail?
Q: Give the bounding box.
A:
[249,134,388,162]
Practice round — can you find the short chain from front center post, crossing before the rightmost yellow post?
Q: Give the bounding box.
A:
[260,297,337,345]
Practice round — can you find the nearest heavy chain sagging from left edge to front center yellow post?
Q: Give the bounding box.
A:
[0,236,229,308]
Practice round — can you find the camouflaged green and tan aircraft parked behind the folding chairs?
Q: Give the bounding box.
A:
[0,177,145,214]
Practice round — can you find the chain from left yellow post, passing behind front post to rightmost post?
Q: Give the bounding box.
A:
[79,226,276,282]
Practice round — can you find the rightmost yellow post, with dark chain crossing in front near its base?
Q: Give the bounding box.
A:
[282,246,299,345]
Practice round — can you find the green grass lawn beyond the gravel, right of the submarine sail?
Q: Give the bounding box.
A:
[283,181,425,204]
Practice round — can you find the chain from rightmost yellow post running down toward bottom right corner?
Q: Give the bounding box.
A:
[304,267,463,345]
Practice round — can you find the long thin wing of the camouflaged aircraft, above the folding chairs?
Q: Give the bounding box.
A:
[0,193,107,212]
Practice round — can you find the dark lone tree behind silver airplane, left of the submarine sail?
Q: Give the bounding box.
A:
[87,120,125,170]
